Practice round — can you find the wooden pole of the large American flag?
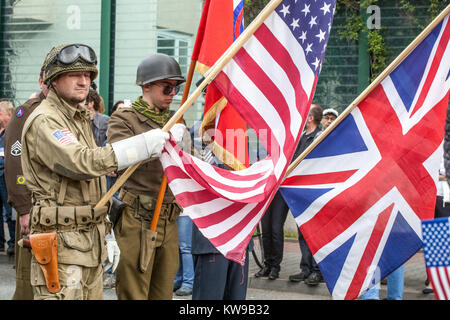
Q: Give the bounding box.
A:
[95,0,282,208]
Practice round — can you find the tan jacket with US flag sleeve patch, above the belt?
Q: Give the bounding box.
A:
[22,91,117,206]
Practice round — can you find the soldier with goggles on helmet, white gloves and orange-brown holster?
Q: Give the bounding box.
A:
[22,44,169,299]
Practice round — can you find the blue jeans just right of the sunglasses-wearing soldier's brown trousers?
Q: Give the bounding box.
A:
[173,216,194,289]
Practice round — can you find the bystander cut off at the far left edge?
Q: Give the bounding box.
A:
[0,101,15,256]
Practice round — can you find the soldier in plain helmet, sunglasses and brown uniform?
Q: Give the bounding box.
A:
[108,53,189,300]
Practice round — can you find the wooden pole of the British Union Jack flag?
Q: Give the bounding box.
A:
[285,5,450,177]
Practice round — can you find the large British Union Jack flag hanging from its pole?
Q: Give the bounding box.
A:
[281,16,450,299]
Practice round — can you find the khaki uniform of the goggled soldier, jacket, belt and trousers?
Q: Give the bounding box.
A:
[22,91,117,299]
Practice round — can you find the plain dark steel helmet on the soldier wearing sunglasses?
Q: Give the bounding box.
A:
[136,53,186,86]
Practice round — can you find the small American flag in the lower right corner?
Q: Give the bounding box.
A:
[422,218,450,300]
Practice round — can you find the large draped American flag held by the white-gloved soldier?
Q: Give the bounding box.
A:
[161,0,335,264]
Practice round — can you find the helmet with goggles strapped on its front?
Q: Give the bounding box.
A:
[44,44,98,86]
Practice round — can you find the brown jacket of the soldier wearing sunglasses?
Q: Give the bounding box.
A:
[107,102,175,203]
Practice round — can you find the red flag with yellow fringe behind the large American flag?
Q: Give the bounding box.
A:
[192,0,249,170]
